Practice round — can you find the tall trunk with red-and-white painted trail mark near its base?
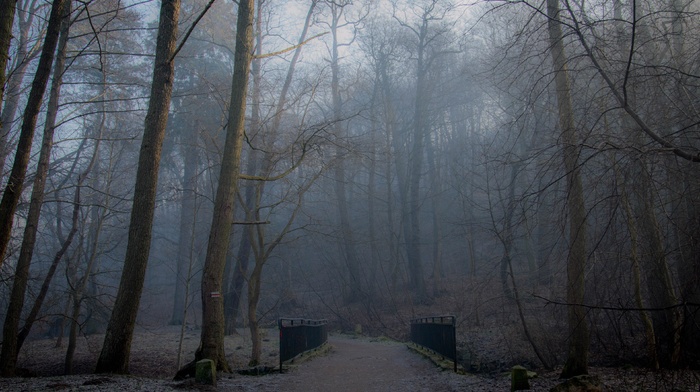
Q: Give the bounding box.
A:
[195,0,255,371]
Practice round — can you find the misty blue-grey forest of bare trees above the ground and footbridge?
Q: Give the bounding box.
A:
[0,0,700,378]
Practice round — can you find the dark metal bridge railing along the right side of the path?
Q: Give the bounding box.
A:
[411,316,457,372]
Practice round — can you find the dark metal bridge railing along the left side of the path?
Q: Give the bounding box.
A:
[277,318,328,372]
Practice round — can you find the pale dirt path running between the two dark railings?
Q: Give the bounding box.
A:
[219,336,474,392]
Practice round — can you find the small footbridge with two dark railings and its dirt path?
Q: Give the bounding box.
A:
[213,316,484,392]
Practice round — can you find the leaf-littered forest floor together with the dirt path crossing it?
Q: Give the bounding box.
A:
[0,327,700,392]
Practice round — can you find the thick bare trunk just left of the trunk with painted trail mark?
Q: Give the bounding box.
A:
[95,0,180,373]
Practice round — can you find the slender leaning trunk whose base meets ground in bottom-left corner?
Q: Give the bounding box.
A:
[0,2,71,376]
